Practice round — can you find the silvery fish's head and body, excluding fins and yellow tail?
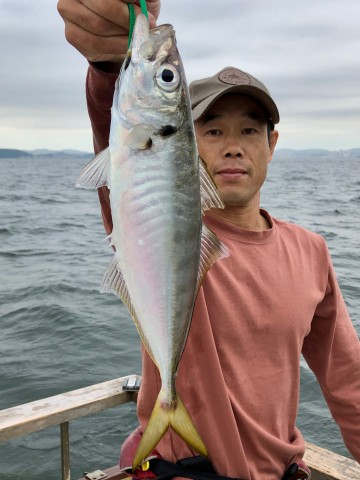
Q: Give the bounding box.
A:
[110,25,202,394]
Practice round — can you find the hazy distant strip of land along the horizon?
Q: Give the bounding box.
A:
[0,148,360,160]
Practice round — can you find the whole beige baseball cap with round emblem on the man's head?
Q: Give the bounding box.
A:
[189,67,280,123]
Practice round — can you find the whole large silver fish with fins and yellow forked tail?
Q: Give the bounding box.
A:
[77,14,227,469]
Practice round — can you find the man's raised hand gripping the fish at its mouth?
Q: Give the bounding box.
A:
[57,0,160,68]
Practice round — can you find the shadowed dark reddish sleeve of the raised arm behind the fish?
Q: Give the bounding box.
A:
[86,64,118,235]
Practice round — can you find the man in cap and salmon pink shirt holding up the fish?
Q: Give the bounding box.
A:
[58,0,360,480]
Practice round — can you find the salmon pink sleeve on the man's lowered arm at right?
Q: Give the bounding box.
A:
[302,247,360,463]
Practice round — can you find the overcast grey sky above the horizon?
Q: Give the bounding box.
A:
[0,0,360,151]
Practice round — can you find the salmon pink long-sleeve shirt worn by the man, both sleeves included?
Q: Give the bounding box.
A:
[87,66,360,480]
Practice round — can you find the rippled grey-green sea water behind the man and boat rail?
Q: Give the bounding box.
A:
[0,155,360,480]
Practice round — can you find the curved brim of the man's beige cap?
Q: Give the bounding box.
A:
[192,85,280,123]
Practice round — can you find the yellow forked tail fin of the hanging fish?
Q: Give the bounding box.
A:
[132,392,208,470]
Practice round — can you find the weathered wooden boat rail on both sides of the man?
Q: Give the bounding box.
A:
[0,375,360,480]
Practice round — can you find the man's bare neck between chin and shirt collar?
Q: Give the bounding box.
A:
[206,206,271,232]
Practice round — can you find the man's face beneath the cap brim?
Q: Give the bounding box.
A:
[195,94,278,207]
